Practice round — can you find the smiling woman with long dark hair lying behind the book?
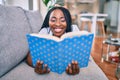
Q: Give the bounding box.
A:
[27,7,79,75]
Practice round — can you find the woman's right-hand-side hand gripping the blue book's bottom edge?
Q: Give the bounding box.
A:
[66,61,80,75]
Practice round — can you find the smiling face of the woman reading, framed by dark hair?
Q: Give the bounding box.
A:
[49,9,67,37]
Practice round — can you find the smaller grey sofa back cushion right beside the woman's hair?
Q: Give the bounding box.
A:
[25,11,43,33]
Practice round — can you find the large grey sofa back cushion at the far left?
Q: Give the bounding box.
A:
[0,5,31,76]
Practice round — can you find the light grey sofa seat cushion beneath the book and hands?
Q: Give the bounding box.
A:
[1,58,108,80]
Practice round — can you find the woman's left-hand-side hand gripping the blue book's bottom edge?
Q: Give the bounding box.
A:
[35,60,50,74]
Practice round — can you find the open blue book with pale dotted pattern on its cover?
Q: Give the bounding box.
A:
[27,31,94,74]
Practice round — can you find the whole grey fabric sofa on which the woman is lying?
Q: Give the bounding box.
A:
[0,5,108,80]
